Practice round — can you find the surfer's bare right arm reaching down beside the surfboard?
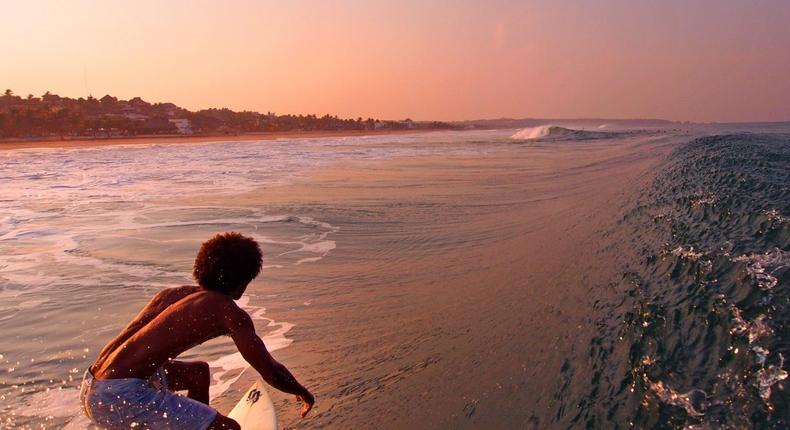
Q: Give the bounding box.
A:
[228,305,315,417]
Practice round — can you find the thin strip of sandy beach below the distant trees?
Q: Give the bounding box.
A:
[0,128,446,151]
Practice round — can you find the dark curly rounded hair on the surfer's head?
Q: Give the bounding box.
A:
[192,232,263,294]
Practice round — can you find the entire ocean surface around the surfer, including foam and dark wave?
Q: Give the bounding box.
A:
[0,125,790,428]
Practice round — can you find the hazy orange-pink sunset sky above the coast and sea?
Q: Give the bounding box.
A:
[0,0,790,121]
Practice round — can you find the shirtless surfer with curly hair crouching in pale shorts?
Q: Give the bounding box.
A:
[80,233,315,430]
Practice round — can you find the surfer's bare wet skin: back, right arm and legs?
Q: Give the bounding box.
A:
[90,285,315,429]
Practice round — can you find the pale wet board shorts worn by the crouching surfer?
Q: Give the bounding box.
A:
[80,370,217,430]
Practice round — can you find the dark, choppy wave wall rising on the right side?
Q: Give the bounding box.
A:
[556,134,790,429]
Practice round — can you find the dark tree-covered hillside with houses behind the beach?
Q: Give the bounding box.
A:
[0,89,455,138]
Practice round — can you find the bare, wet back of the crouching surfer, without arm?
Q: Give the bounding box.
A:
[91,286,246,379]
